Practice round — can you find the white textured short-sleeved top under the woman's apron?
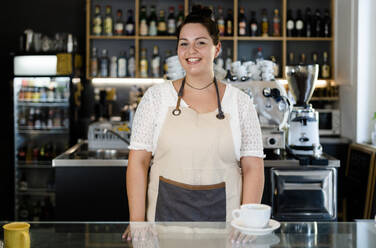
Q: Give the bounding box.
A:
[129,81,264,161]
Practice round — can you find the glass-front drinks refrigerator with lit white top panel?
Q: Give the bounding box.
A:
[13,55,72,221]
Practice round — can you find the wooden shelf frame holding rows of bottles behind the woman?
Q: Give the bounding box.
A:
[86,0,336,80]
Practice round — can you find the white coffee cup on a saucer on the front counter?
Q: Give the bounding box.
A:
[232,204,271,228]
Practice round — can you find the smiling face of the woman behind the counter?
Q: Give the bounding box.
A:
[178,23,221,75]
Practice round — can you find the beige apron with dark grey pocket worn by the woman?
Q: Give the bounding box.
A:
[147,79,242,221]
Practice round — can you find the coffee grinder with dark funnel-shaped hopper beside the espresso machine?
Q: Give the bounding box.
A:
[285,64,321,157]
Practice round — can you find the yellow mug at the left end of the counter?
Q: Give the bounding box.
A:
[3,222,30,248]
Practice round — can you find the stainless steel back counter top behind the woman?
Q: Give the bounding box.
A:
[52,141,340,168]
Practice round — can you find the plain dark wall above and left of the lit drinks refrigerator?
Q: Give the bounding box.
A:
[0,0,86,220]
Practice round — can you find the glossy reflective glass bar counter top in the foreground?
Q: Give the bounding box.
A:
[0,220,376,248]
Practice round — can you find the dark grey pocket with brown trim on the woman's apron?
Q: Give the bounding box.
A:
[155,177,226,221]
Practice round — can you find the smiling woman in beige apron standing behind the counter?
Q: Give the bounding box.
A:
[124,4,264,242]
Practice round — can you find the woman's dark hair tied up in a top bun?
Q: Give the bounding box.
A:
[176,5,219,45]
